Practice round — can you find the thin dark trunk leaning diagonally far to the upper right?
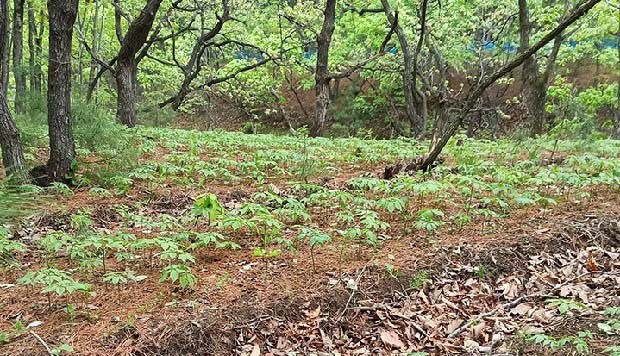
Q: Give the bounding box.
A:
[414,0,601,171]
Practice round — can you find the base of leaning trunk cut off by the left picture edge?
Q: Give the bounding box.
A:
[0,94,26,181]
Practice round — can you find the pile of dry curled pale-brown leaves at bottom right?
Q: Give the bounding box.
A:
[229,218,620,355]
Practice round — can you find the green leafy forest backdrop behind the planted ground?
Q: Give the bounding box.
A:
[1,0,620,186]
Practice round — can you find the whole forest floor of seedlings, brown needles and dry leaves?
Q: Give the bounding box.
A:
[0,130,620,356]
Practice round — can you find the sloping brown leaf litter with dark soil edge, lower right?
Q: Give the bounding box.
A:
[126,216,620,356]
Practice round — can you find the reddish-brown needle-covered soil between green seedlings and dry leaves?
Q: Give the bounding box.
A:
[0,181,620,355]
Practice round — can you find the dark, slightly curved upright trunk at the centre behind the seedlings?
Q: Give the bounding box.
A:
[310,0,336,137]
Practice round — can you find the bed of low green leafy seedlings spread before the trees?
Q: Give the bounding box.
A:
[0,124,620,354]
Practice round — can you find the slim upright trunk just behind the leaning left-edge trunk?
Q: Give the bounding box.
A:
[13,0,26,114]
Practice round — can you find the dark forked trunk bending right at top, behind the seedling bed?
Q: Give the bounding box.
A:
[115,0,162,127]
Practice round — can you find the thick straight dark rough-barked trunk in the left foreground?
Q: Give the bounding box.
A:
[47,0,78,182]
